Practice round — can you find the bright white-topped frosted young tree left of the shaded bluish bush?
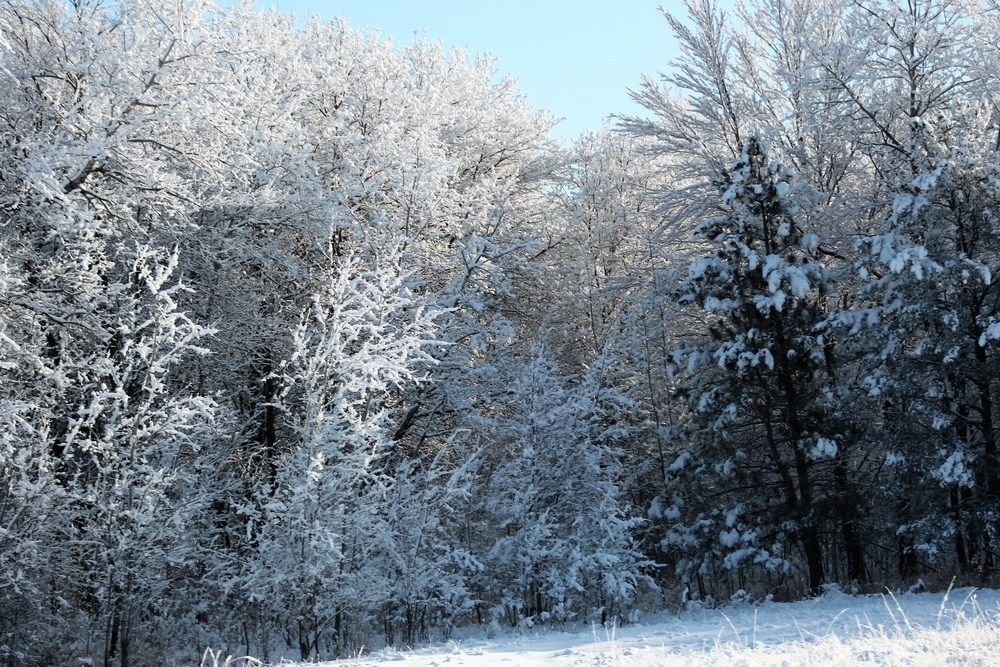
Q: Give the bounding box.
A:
[244,255,438,660]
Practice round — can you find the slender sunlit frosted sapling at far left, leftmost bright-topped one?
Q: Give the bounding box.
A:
[60,248,216,665]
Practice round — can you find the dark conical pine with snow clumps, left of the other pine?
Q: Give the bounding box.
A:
[656,137,849,593]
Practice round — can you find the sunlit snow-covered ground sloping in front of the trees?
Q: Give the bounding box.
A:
[270,588,1000,667]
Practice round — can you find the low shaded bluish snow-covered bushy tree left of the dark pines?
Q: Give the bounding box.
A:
[468,350,648,625]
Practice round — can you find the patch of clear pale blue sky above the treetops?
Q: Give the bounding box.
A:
[258,0,684,136]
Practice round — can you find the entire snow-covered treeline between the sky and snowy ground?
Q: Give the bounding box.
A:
[0,0,1000,667]
